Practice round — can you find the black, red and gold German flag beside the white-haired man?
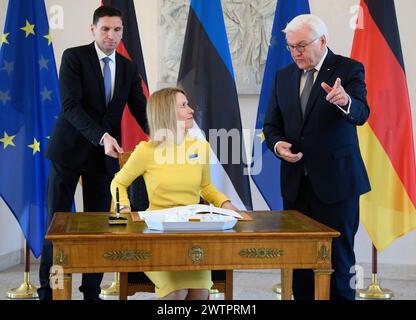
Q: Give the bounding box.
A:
[351,0,416,251]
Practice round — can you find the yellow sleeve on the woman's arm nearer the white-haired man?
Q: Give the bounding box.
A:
[201,142,229,207]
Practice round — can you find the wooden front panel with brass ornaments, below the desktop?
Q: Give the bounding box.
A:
[54,238,331,272]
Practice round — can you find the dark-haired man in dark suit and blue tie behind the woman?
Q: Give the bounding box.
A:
[38,6,147,300]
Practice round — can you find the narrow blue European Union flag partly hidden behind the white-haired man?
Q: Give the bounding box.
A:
[252,0,310,210]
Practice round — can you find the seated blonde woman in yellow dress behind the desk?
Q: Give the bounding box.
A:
[111,88,237,300]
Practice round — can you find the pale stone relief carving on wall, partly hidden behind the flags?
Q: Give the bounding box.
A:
[158,0,277,93]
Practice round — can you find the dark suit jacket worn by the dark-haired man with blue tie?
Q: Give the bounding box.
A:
[46,43,147,173]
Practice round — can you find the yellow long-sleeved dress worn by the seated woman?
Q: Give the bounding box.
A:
[111,136,228,298]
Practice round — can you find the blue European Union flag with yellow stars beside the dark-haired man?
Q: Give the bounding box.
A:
[0,0,60,257]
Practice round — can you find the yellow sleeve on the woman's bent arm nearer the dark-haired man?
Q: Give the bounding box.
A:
[111,141,149,206]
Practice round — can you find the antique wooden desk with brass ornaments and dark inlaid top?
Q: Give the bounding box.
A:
[46,211,339,300]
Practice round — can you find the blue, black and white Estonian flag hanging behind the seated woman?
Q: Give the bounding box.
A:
[178,0,252,210]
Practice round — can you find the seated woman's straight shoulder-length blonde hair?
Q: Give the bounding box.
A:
[147,87,186,144]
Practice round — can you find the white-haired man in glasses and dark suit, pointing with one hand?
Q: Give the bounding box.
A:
[263,15,370,299]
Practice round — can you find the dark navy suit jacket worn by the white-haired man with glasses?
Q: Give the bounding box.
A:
[263,50,370,203]
